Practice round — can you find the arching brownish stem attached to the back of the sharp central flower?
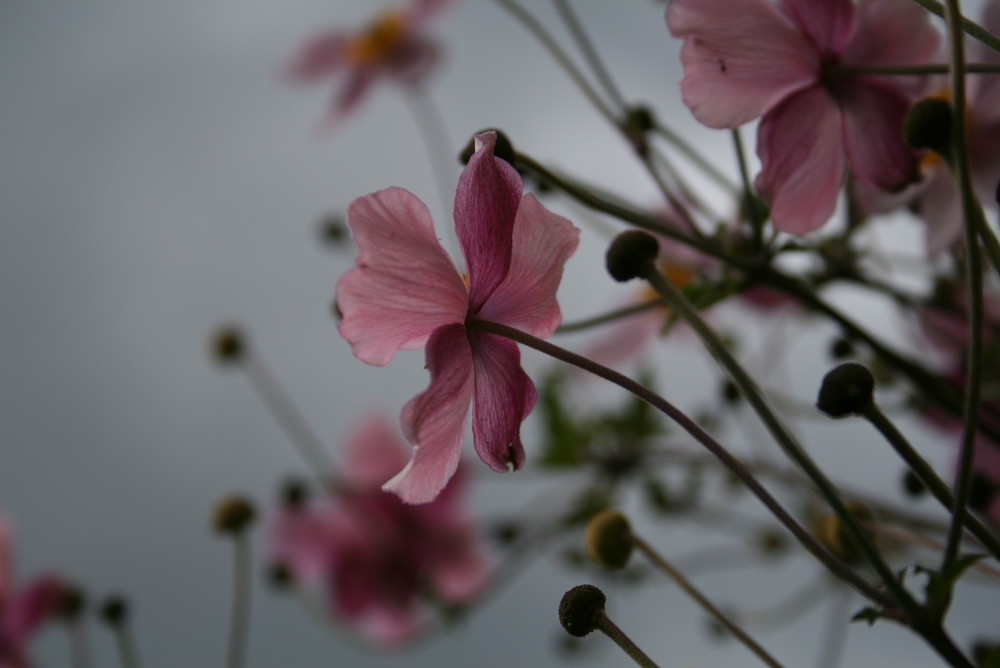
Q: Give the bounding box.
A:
[466,320,895,607]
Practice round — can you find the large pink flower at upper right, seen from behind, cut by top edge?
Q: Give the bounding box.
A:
[667,0,939,234]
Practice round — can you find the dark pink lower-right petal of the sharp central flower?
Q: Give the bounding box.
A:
[470,332,538,473]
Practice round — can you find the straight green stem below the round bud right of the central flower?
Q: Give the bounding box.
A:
[640,260,920,618]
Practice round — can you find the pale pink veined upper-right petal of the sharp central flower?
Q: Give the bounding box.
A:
[477,195,580,338]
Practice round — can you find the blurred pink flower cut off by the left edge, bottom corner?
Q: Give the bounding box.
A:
[0,518,62,668]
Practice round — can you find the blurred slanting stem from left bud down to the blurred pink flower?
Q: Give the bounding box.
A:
[242,351,336,489]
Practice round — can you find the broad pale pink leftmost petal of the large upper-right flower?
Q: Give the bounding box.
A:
[667,0,820,128]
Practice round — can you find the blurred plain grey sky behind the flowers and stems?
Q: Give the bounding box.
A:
[0,0,995,668]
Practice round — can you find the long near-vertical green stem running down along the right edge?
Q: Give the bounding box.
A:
[941,0,983,572]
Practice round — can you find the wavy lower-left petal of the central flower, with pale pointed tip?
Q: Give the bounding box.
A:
[382,325,474,503]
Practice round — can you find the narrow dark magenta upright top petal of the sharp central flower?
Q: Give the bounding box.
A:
[455,132,524,313]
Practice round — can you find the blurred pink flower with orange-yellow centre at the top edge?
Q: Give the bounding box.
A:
[288,0,452,122]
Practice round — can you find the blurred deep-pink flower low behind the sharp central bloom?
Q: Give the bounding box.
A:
[271,417,485,644]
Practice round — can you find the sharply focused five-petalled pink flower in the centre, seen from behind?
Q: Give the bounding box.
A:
[337,132,579,503]
